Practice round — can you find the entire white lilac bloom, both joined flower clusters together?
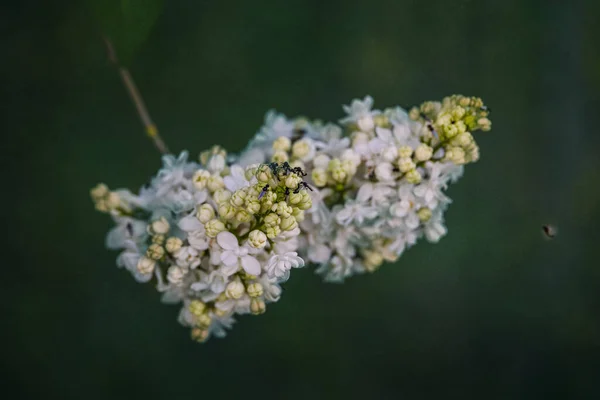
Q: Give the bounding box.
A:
[91,95,491,341]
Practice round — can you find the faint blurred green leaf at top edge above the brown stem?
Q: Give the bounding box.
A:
[87,0,163,65]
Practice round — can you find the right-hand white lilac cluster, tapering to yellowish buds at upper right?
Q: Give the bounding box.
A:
[237,95,491,282]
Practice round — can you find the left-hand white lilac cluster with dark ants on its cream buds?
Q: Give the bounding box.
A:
[91,147,312,341]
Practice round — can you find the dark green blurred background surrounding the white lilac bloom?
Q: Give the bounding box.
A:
[0,0,600,399]
